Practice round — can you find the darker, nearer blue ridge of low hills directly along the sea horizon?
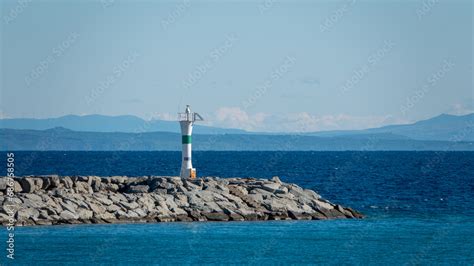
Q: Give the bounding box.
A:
[0,128,474,151]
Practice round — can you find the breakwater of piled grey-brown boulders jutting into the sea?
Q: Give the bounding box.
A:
[0,176,362,225]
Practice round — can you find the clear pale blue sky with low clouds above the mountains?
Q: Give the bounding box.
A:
[0,0,474,132]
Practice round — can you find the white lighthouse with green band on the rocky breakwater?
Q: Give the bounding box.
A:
[178,105,204,178]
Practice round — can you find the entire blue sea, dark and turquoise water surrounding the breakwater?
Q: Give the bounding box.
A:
[0,151,474,265]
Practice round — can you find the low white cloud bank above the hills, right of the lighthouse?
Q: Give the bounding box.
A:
[200,107,409,132]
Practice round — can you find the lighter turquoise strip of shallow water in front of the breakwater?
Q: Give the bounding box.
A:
[12,217,474,265]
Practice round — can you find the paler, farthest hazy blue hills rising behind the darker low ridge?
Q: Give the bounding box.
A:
[0,114,474,141]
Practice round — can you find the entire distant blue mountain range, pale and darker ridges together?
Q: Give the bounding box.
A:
[0,114,474,151]
